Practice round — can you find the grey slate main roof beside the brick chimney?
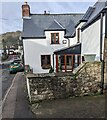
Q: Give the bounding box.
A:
[22,14,83,38]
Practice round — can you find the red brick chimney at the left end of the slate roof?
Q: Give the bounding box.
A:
[22,2,30,17]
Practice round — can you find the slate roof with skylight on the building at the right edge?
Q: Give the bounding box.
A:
[82,0,107,30]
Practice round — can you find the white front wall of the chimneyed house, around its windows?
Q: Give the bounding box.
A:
[23,31,68,73]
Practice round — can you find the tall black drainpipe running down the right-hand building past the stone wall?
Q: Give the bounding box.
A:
[100,13,104,94]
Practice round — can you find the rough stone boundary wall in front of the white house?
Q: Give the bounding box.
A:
[27,62,101,103]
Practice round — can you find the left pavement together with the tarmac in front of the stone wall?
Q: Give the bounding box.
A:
[2,72,106,119]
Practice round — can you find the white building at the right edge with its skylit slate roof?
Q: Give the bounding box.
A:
[81,0,107,61]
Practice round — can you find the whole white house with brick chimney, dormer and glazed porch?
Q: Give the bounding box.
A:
[22,3,83,73]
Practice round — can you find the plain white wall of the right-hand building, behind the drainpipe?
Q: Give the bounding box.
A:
[81,16,105,61]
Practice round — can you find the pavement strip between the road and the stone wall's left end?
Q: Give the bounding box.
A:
[2,72,36,118]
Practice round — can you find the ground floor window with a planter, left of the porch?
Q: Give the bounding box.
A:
[41,55,51,69]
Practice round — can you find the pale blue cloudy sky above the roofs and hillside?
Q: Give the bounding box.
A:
[0,0,97,34]
